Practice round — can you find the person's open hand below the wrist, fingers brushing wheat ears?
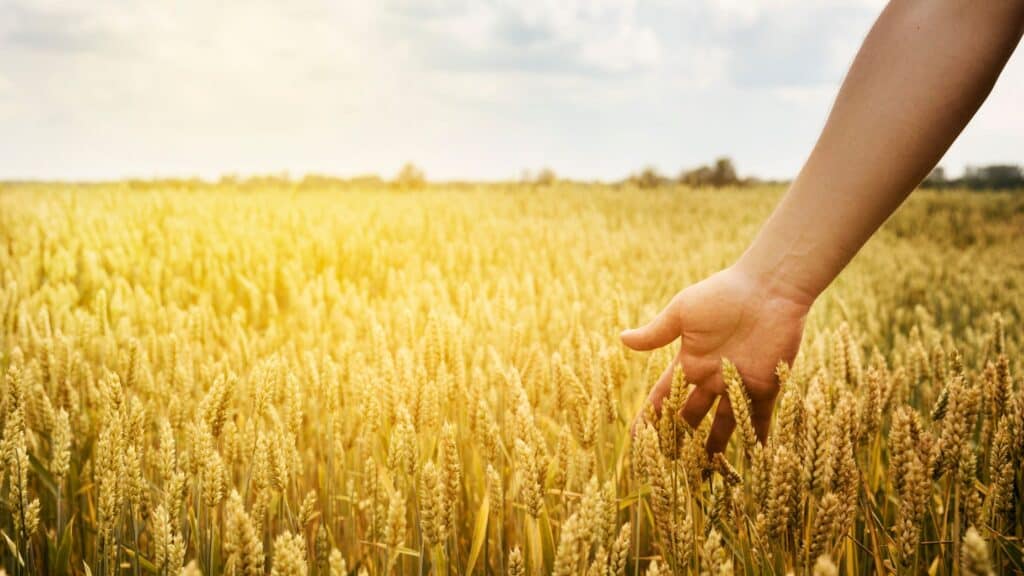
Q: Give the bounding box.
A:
[622,266,810,452]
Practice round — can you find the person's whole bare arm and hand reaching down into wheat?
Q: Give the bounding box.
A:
[622,0,1024,452]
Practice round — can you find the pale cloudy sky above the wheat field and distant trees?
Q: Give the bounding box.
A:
[0,0,1024,179]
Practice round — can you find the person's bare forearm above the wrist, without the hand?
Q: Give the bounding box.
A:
[737,0,1024,304]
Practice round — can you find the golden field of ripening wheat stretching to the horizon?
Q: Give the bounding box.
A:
[0,179,1024,576]
